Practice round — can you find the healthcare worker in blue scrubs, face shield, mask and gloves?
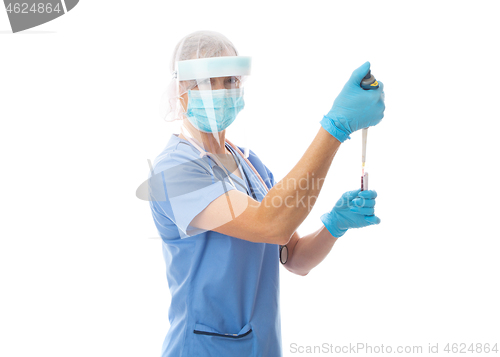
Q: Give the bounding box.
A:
[149,31,385,357]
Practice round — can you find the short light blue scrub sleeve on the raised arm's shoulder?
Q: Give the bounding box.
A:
[149,136,237,238]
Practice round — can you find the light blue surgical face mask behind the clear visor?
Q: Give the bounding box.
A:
[186,88,245,133]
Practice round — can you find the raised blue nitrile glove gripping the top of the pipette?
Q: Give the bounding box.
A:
[320,62,385,142]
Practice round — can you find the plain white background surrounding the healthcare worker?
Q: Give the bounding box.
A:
[0,0,500,356]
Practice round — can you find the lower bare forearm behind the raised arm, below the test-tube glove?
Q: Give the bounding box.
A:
[286,226,337,275]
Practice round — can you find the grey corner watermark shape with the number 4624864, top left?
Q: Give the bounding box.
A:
[4,0,79,32]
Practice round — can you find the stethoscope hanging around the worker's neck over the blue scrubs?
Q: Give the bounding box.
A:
[181,126,288,264]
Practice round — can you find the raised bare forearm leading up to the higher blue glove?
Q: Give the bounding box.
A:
[259,128,340,241]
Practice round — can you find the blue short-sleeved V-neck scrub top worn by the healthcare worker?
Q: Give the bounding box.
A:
[150,135,282,357]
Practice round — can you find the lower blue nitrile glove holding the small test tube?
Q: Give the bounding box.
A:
[321,189,380,238]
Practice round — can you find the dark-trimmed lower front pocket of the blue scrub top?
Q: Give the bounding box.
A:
[192,324,254,357]
